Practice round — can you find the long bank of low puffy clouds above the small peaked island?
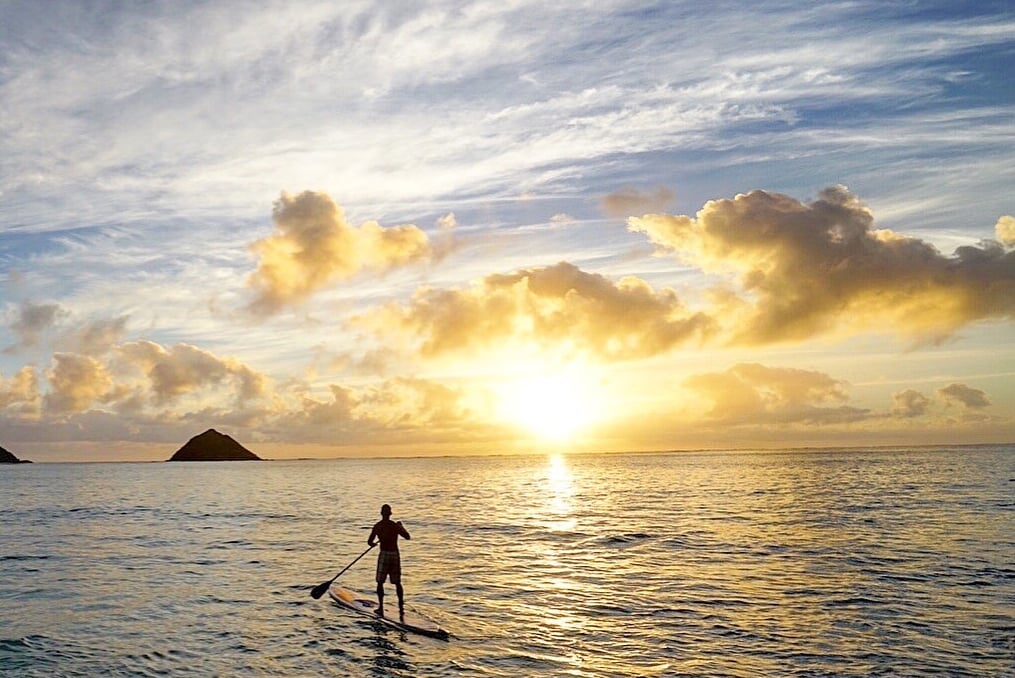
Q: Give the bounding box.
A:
[0,340,486,445]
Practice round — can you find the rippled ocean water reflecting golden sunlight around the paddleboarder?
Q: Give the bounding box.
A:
[0,447,1015,678]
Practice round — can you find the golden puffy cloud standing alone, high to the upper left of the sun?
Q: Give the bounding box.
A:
[248,191,434,314]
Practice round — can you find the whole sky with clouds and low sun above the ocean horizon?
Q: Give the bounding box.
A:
[0,0,1015,462]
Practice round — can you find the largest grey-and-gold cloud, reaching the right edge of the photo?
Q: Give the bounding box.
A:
[628,186,1015,344]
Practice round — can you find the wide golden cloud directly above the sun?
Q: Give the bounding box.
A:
[358,262,712,360]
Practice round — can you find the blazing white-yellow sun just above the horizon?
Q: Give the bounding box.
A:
[497,369,601,444]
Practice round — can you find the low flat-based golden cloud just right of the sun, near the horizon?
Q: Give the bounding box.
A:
[684,363,869,425]
